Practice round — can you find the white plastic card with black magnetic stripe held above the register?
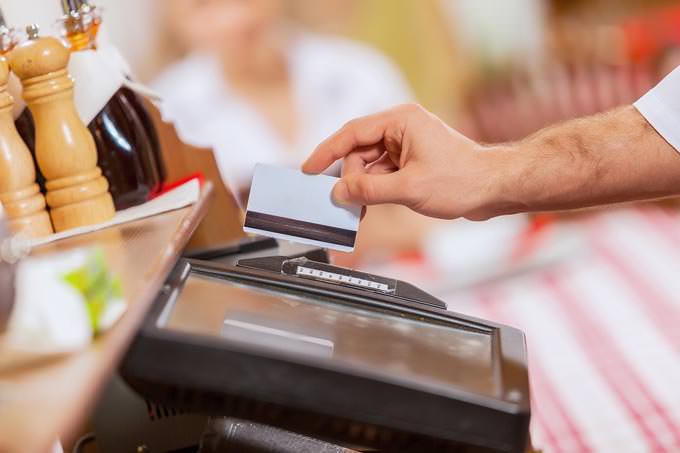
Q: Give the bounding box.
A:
[243,164,361,252]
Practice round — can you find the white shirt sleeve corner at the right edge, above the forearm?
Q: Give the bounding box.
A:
[633,66,680,151]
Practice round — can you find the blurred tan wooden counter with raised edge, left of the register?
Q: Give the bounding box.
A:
[0,184,212,453]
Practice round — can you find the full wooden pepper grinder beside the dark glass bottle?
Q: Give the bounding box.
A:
[10,25,115,232]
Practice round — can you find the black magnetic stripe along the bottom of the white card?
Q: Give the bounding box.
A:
[245,211,357,247]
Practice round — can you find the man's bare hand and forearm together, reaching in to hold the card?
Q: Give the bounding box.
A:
[303,105,680,220]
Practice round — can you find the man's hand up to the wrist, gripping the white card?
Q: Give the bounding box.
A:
[302,105,504,219]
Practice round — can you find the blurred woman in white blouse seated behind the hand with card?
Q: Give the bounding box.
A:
[154,0,411,199]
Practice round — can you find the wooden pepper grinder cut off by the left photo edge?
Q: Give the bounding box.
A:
[0,56,52,238]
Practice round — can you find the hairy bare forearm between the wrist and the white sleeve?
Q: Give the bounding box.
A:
[487,106,680,215]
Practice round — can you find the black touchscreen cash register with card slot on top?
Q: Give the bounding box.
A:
[121,237,530,452]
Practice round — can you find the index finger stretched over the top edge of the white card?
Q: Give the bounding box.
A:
[302,107,408,174]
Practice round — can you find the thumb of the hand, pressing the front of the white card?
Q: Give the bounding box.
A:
[333,173,408,206]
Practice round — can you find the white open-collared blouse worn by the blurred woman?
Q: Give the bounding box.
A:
[154,33,412,191]
